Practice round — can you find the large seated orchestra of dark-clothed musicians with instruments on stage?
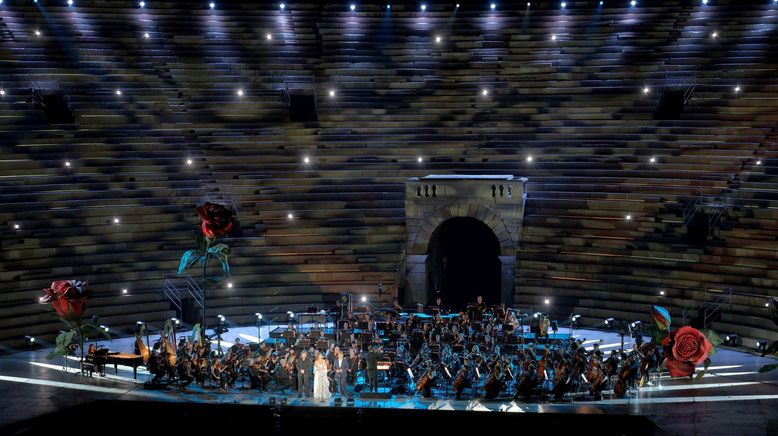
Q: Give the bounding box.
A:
[136,297,661,401]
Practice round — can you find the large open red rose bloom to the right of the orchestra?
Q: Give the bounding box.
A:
[662,326,713,377]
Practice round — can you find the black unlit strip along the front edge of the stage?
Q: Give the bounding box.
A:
[6,400,663,436]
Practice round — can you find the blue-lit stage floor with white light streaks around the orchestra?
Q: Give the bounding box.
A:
[0,326,778,435]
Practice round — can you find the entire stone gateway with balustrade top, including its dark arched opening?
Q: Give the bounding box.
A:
[403,175,527,308]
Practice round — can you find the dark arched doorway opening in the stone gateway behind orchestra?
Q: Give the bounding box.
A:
[426,217,501,310]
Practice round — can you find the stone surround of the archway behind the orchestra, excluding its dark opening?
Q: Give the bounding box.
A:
[403,175,527,306]
